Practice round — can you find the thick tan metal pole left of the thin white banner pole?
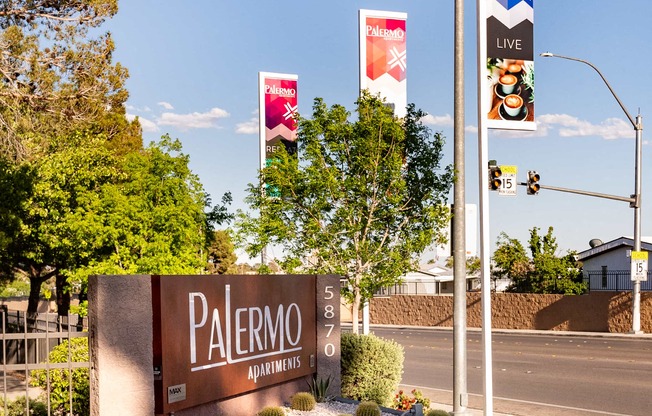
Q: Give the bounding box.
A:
[452,0,468,415]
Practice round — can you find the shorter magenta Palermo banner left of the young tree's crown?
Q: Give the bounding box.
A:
[258,72,299,169]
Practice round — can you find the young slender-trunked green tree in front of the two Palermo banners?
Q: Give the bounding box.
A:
[237,93,453,333]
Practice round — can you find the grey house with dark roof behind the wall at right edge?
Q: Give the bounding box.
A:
[577,237,652,291]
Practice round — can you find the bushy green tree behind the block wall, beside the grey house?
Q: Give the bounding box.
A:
[492,227,586,295]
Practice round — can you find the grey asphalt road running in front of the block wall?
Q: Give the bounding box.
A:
[372,327,652,416]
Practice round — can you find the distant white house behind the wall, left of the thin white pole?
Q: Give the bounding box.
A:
[376,264,480,296]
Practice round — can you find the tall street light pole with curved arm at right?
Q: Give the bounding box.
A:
[541,52,643,334]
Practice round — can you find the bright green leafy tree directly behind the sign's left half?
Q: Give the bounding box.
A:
[67,136,223,281]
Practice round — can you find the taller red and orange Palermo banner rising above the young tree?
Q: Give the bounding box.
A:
[359,10,407,117]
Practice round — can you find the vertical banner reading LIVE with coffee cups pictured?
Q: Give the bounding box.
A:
[482,0,536,130]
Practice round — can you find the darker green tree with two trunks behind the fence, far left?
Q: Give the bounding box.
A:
[0,134,117,314]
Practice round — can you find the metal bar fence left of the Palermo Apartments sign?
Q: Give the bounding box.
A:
[0,308,89,415]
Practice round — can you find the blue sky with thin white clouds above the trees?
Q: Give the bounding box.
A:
[105,0,652,262]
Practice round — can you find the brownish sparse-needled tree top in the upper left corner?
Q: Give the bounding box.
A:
[0,0,135,160]
